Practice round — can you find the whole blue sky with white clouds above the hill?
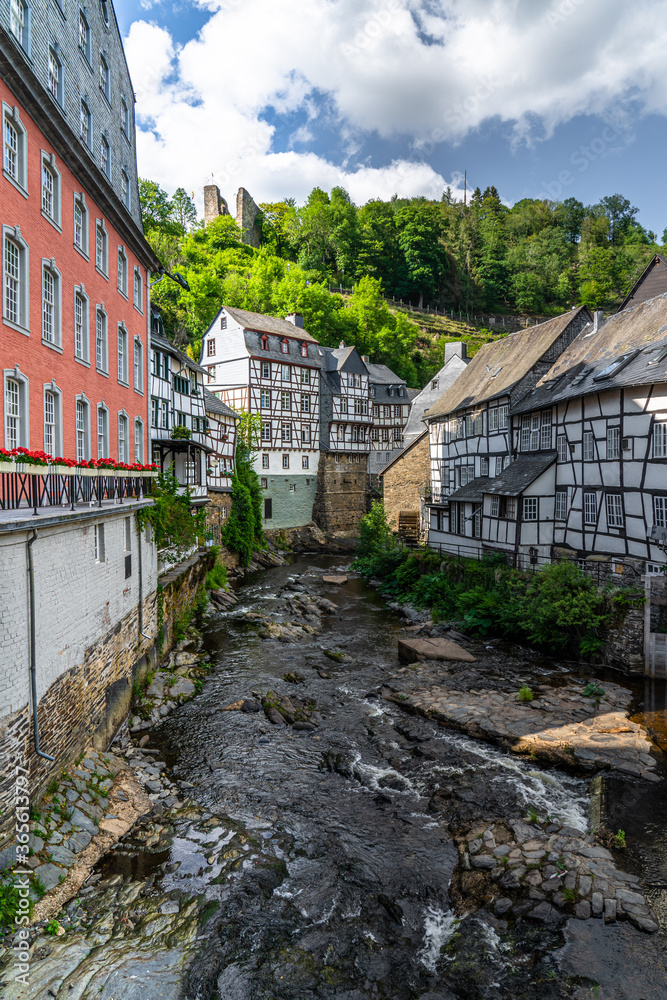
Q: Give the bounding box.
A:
[115,0,667,239]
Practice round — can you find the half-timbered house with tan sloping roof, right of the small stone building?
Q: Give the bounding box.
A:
[424,307,591,554]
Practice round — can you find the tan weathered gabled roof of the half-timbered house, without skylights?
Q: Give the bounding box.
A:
[424,306,590,418]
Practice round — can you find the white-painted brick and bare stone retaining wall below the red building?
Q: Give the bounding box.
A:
[0,511,213,848]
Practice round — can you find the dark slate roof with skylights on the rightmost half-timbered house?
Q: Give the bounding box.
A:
[512,293,667,413]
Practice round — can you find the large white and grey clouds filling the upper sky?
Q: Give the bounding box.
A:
[126,0,667,207]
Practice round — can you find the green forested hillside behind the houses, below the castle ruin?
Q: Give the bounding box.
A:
[141,181,665,387]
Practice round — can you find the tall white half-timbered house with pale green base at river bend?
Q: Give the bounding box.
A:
[201,306,325,528]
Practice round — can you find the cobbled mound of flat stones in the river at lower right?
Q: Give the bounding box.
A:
[452,820,658,933]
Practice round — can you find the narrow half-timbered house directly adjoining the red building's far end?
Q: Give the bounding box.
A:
[150,309,211,503]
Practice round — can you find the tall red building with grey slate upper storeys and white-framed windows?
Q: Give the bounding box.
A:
[0,0,158,462]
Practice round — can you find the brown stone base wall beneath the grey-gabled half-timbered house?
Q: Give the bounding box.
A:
[313,452,369,535]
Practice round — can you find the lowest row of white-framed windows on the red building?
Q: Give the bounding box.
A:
[4,375,144,462]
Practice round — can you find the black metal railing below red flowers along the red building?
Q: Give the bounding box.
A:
[0,469,155,514]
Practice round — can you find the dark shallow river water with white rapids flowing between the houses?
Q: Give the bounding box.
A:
[27,557,667,1000]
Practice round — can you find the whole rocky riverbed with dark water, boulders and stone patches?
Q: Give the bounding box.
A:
[6,557,667,1000]
